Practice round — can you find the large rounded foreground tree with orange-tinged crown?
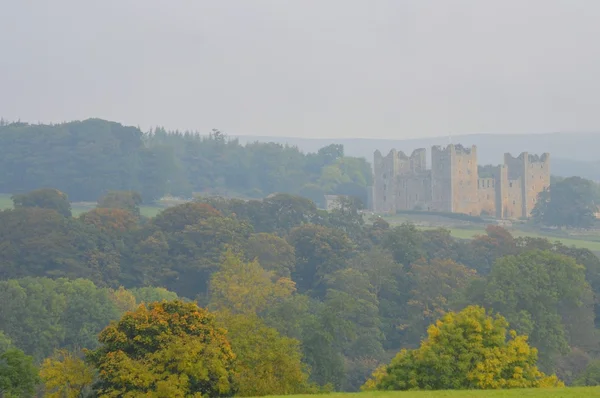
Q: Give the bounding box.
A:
[88,300,235,397]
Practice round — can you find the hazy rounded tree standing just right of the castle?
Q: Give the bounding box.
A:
[531,177,598,228]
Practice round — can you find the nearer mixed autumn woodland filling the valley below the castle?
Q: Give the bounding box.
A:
[0,189,600,396]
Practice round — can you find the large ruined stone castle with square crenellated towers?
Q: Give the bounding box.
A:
[372,145,550,219]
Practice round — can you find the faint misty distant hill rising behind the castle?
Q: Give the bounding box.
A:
[236,133,600,181]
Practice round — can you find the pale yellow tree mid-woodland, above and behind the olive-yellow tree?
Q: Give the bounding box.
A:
[210,251,295,314]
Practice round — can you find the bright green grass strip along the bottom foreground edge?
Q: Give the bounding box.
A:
[270,387,600,398]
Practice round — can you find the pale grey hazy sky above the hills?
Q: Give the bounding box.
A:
[0,0,600,138]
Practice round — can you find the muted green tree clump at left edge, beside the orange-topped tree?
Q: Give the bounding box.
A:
[0,278,121,361]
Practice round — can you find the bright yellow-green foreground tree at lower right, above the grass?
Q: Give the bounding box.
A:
[366,306,564,390]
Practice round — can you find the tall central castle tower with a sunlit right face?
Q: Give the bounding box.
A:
[431,144,481,215]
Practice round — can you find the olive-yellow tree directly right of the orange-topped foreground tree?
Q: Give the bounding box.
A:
[218,312,313,397]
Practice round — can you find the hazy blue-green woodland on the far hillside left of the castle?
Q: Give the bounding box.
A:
[0,119,372,205]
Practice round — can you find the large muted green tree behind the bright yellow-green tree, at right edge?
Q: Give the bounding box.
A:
[484,251,597,369]
